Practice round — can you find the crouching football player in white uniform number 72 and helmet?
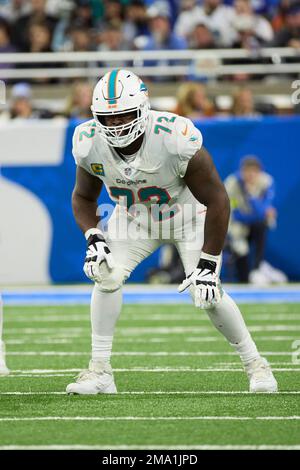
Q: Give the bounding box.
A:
[67,70,277,394]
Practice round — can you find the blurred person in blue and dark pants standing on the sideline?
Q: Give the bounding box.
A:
[225,156,276,282]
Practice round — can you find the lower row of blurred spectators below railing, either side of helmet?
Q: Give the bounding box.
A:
[0,80,300,122]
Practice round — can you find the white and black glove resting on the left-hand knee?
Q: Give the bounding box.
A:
[83,228,115,282]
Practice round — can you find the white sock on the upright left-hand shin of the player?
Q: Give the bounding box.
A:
[91,285,122,362]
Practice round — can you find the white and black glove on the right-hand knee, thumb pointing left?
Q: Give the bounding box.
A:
[178,252,222,309]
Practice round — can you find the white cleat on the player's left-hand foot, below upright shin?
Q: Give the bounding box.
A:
[66,361,117,395]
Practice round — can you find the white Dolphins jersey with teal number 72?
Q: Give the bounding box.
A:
[73,111,205,229]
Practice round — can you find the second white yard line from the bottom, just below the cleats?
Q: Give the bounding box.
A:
[0,416,300,422]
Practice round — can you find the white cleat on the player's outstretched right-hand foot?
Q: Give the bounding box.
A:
[245,357,278,393]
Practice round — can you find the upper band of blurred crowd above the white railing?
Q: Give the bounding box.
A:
[0,0,300,58]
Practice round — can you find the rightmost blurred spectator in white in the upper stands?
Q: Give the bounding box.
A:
[232,0,273,49]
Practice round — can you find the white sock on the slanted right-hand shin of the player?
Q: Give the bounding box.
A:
[206,292,260,364]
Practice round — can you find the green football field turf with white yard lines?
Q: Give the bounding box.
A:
[0,304,300,449]
